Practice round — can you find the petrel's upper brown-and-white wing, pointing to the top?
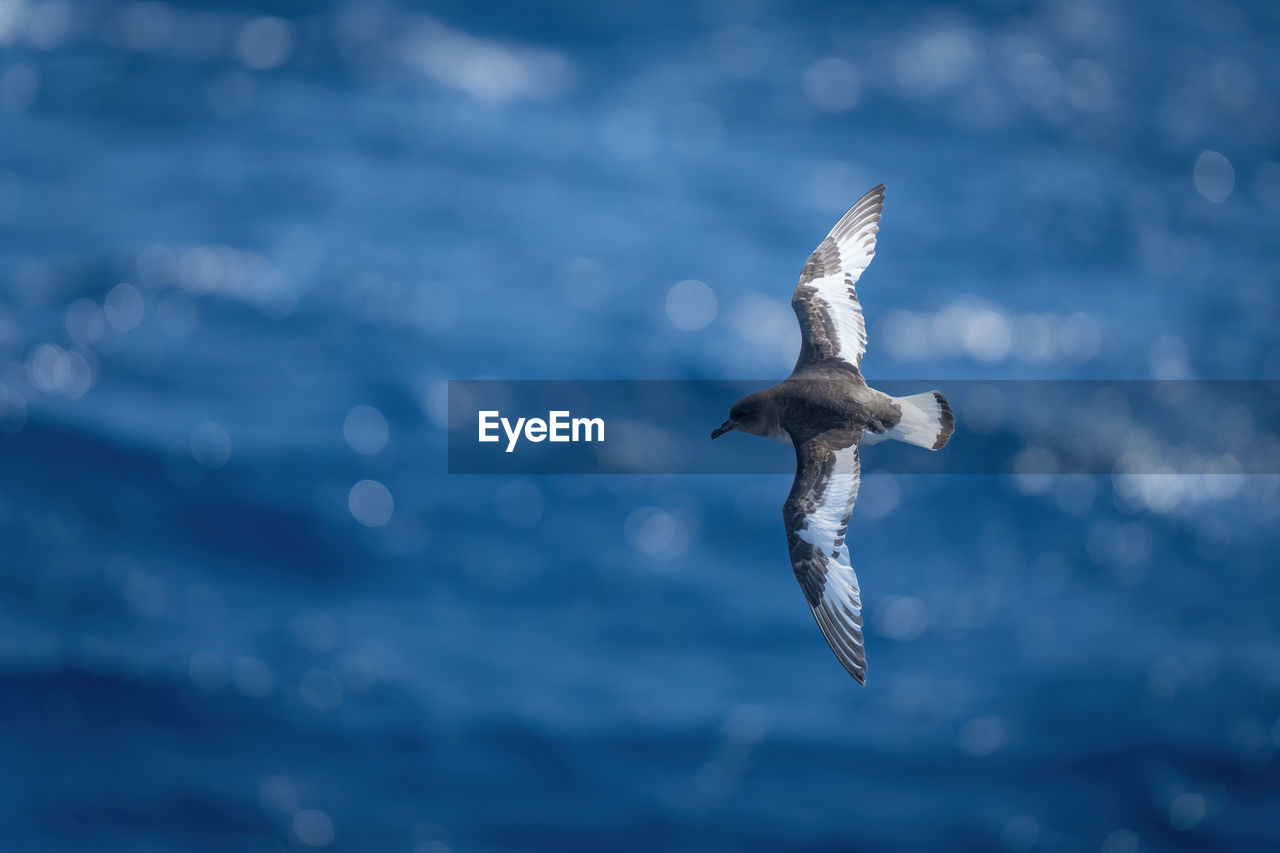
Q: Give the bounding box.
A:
[791,183,884,371]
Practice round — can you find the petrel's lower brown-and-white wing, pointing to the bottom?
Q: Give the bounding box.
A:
[782,430,867,684]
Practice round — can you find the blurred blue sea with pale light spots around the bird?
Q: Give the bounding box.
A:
[0,0,1280,853]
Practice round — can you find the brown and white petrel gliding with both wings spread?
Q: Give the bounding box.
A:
[712,184,955,684]
